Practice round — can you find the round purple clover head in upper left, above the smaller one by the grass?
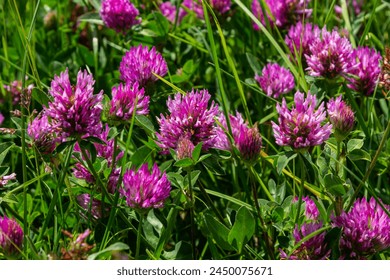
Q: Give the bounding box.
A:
[119,45,168,87]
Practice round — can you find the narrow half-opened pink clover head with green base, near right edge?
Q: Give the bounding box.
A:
[327,95,355,141]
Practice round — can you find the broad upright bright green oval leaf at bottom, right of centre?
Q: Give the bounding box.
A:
[228,207,255,252]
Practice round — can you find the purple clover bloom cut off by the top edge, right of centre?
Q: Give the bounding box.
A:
[252,0,312,30]
